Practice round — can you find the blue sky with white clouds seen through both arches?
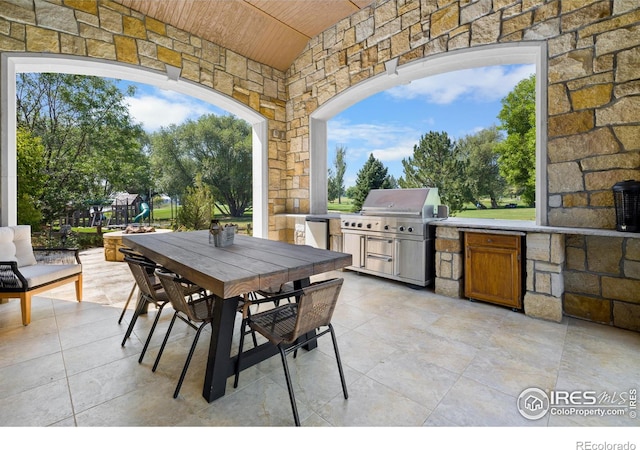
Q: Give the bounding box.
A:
[116,65,535,187]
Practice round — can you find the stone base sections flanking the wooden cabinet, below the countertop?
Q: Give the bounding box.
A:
[435,226,640,331]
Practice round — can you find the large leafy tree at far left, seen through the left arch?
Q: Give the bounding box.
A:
[16,73,150,223]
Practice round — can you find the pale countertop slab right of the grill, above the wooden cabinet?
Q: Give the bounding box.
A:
[429,217,640,238]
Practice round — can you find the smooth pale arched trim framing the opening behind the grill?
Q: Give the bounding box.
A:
[310,42,547,225]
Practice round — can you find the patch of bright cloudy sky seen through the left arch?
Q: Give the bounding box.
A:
[125,88,219,132]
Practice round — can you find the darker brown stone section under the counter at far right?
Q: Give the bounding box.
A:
[564,235,640,331]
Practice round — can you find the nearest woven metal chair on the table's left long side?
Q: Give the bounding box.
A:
[151,271,242,398]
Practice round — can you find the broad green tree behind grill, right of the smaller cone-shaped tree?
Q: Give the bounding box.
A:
[398,131,470,214]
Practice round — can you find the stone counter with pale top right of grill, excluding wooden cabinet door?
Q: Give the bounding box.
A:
[429,217,640,329]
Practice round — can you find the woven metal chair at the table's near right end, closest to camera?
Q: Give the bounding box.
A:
[234,278,349,426]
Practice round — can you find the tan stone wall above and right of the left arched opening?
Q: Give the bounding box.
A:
[0,0,292,240]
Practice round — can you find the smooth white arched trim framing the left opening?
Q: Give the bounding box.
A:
[0,53,268,237]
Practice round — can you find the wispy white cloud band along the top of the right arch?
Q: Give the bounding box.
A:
[387,65,535,105]
